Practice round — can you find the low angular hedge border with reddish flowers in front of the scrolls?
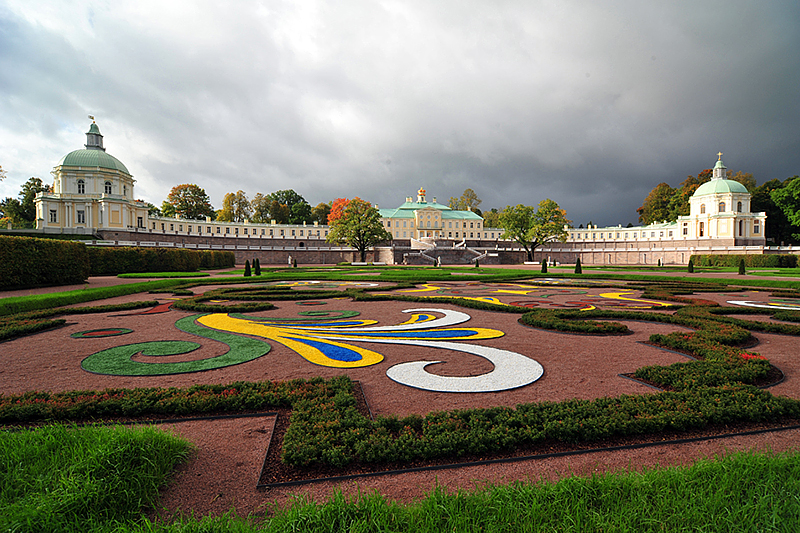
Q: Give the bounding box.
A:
[6,278,800,469]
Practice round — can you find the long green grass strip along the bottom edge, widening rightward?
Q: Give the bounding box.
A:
[125,446,800,533]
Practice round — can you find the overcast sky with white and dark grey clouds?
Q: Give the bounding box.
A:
[0,0,800,226]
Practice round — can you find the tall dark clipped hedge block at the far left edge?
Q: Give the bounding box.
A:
[0,236,90,290]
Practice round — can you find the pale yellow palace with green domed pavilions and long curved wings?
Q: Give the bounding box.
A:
[26,120,780,264]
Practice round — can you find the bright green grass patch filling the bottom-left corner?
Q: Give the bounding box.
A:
[0,425,191,532]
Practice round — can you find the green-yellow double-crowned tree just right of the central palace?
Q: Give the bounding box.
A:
[500,198,572,262]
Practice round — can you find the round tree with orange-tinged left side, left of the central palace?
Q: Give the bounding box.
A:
[327,196,392,262]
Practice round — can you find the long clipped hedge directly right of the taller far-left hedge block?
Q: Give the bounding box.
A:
[88,246,234,276]
